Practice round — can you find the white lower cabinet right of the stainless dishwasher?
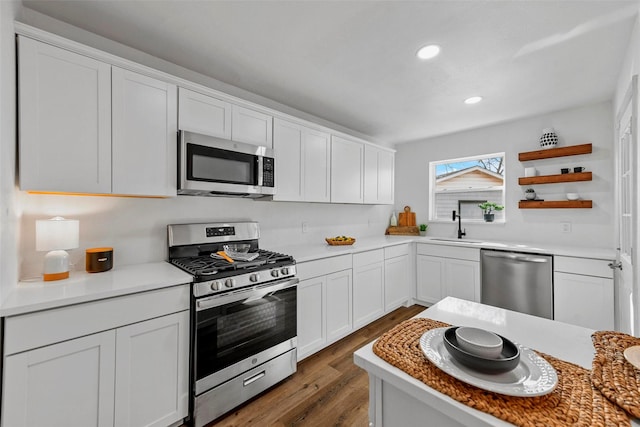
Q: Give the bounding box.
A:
[553,256,615,330]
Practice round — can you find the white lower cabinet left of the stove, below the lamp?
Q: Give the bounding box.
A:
[2,285,189,427]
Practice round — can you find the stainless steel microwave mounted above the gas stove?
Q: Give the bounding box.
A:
[178,131,275,198]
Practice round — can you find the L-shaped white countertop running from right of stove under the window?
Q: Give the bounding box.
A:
[274,235,616,262]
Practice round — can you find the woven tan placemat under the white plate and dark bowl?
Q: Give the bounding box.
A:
[373,318,631,427]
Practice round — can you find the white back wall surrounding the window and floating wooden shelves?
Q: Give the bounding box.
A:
[395,102,614,248]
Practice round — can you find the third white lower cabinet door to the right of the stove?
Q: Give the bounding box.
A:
[353,262,384,329]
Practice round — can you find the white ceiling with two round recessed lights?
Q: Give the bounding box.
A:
[23,0,638,143]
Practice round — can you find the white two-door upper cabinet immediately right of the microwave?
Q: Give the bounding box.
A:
[273,119,331,202]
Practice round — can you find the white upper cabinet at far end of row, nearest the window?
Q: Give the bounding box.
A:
[364,145,395,204]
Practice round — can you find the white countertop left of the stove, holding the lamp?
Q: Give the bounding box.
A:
[0,261,193,317]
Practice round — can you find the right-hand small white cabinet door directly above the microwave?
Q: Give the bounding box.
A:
[231,105,273,148]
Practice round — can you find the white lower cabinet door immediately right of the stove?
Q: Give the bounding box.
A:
[297,276,326,360]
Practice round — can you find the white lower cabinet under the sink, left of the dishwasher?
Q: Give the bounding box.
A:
[416,244,480,303]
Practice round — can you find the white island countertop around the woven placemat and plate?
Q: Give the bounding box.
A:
[354,297,640,427]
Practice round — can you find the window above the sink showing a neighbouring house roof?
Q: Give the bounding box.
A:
[429,153,505,222]
